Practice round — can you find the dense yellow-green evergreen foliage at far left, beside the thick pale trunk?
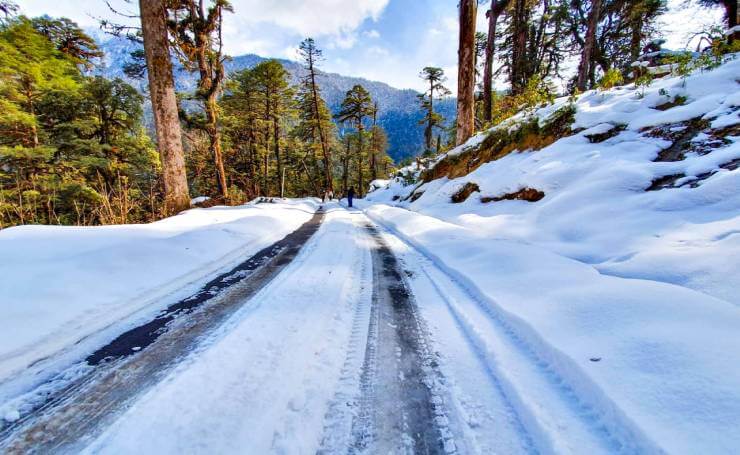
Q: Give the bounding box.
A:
[0,17,159,226]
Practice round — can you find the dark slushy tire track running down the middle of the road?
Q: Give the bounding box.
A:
[349,220,456,453]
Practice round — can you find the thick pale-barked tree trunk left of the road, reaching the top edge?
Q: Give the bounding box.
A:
[139,0,190,215]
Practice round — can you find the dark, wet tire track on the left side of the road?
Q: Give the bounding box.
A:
[0,209,324,453]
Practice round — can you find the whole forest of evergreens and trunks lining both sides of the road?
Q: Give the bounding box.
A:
[0,0,737,228]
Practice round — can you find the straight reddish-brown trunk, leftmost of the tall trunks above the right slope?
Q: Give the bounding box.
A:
[456,0,478,145]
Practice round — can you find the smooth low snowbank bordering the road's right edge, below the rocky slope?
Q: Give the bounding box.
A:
[366,204,740,453]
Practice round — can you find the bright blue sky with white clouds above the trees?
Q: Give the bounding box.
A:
[18,0,720,90]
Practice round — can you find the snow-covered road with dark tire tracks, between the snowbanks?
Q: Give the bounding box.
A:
[0,204,634,454]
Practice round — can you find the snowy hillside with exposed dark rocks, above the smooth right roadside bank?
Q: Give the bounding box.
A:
[367,59,740,304]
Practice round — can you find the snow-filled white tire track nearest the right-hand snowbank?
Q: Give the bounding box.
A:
[368,215,642,453]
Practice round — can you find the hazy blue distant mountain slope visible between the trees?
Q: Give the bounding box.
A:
[91,33,455,161]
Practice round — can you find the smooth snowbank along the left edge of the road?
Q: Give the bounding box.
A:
[0,200,317,381]
